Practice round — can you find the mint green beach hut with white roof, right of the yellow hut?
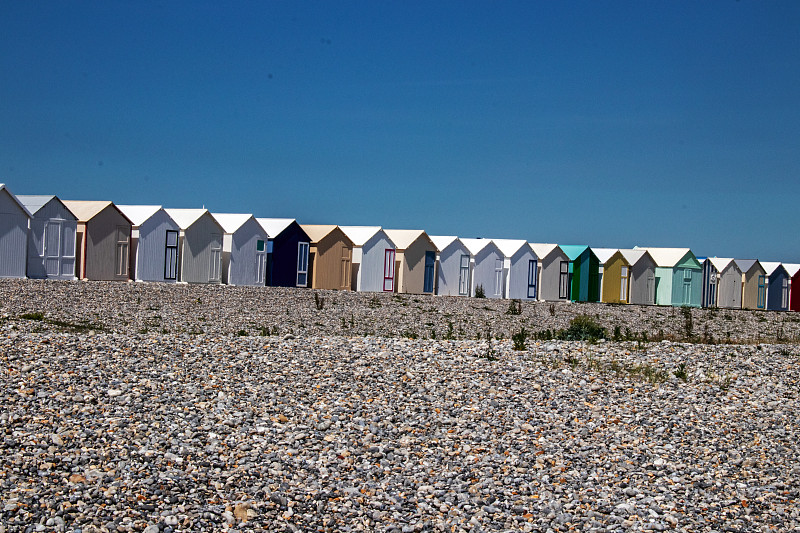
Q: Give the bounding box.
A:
[636,246,703,307]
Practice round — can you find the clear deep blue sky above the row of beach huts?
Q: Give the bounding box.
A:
[0,0,800,262]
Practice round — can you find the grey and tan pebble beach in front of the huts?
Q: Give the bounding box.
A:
[0,281,800,533]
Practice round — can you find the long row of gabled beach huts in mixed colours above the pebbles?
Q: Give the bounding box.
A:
[0,184,800,311]
